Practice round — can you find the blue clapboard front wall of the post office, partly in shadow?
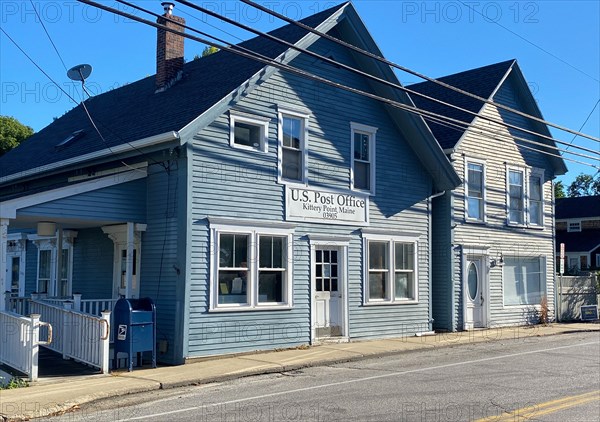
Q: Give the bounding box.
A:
[188,33,432,357]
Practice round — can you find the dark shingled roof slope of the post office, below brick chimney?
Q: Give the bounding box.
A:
[0,3,346,178]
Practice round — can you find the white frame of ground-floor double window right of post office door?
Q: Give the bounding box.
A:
[363,233,419,306]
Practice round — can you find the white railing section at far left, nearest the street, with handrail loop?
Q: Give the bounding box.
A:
[0,312,52,381]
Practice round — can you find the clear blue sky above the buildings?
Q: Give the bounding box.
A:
[0,0,600,184]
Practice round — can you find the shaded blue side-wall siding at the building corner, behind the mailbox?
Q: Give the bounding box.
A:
[140,159,185,363]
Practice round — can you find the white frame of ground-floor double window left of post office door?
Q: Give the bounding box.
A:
[209,222,294,312]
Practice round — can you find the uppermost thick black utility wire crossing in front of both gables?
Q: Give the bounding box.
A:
[240,0,600,142]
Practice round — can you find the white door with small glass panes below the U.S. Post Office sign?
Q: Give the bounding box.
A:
[313,246,344,338]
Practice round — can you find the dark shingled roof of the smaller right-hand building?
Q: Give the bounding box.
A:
[407,60,515,149]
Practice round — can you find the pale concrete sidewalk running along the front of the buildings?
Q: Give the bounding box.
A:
[0,323,600,420]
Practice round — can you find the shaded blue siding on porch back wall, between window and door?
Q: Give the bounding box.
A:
[72,228,114,299]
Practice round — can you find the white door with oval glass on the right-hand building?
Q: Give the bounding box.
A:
[464,256,487,329]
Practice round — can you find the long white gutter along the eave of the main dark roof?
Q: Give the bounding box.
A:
[0,131,180,184]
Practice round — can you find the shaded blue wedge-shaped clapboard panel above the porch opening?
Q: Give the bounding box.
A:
[17,179,146,223]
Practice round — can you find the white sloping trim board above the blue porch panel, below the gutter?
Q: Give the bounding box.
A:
[0,169,148,219]
